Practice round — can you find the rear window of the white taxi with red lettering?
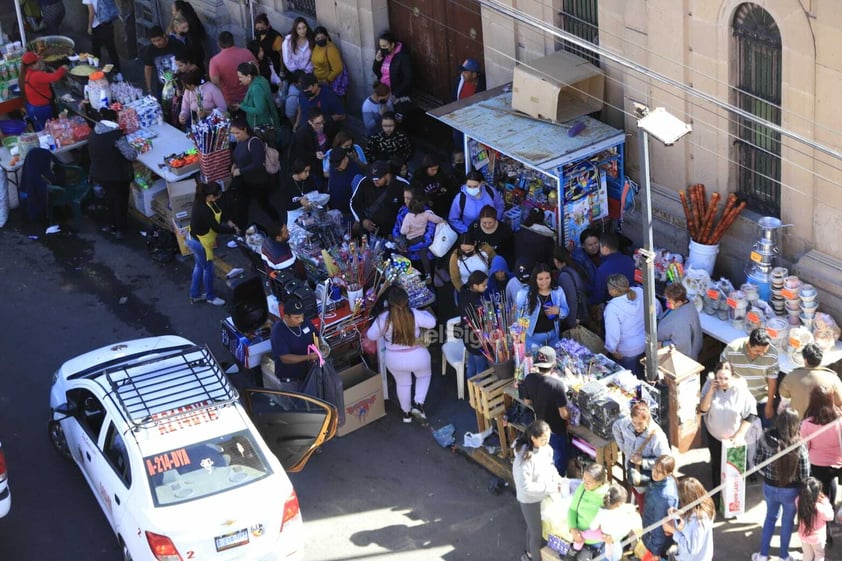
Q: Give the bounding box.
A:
[143,430,272,506]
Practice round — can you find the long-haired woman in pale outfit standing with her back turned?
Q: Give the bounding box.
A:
[366,286,436,423]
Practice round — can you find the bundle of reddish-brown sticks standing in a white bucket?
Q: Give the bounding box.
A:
[678,183,746,245]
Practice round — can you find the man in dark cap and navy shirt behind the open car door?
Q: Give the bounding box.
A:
[271,298,319,392]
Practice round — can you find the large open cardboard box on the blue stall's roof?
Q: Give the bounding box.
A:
[512,51,605,123]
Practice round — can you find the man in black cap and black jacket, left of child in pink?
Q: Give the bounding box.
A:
[351,160,409,235]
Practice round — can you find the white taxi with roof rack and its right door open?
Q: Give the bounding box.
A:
[49,336,337,561]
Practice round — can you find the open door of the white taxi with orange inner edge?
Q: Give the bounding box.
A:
[243,388,338,472]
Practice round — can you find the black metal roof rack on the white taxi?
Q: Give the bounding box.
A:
[105,345,239,428]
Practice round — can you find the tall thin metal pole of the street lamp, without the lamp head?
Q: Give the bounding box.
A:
[637,127,658,382]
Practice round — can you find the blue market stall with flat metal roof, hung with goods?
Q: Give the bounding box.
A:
[430,84,625,247]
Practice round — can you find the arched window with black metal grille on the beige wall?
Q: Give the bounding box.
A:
[733,3,782,216]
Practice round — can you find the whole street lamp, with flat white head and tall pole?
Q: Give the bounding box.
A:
[635,103,693,382]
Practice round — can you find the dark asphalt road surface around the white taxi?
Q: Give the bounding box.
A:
[0,211,524,561]
